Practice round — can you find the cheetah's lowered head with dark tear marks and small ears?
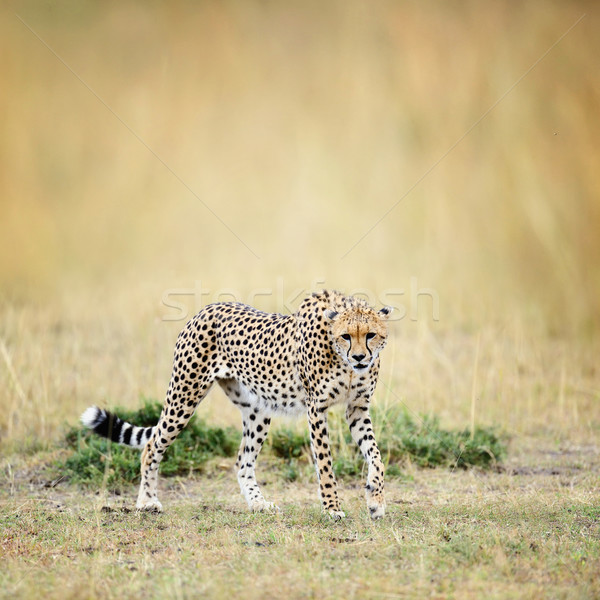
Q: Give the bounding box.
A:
[325,306,392,373]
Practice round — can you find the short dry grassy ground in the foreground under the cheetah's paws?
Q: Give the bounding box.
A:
[0,447,600,599]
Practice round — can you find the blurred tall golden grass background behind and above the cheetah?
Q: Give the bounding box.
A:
[0,0,600,448]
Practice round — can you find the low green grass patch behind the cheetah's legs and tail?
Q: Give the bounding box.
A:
[57,400,506,490]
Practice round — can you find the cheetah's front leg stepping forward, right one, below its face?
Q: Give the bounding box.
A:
[346,403,385,519]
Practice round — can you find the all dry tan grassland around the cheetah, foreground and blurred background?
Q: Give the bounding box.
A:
[0,0,600,599]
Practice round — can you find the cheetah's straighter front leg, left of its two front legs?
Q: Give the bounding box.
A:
[308,404,346,521]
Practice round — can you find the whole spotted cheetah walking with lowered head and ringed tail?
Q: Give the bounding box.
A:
[81,290,392,520]
